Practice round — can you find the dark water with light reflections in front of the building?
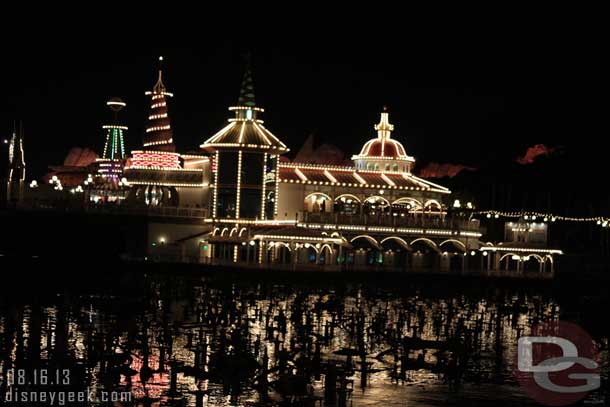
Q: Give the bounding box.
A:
[0,269,608,406]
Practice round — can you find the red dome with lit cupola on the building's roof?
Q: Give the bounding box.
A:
[352,107,415,173]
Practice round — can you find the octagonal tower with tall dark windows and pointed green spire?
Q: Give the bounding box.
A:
[200,64,288,219]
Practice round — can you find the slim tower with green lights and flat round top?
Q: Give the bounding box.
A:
[97,97,127,179]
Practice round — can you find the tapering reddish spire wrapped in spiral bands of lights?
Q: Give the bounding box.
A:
[144,57,176,153]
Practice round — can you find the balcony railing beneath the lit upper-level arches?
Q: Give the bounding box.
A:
[303,212,480,231]
